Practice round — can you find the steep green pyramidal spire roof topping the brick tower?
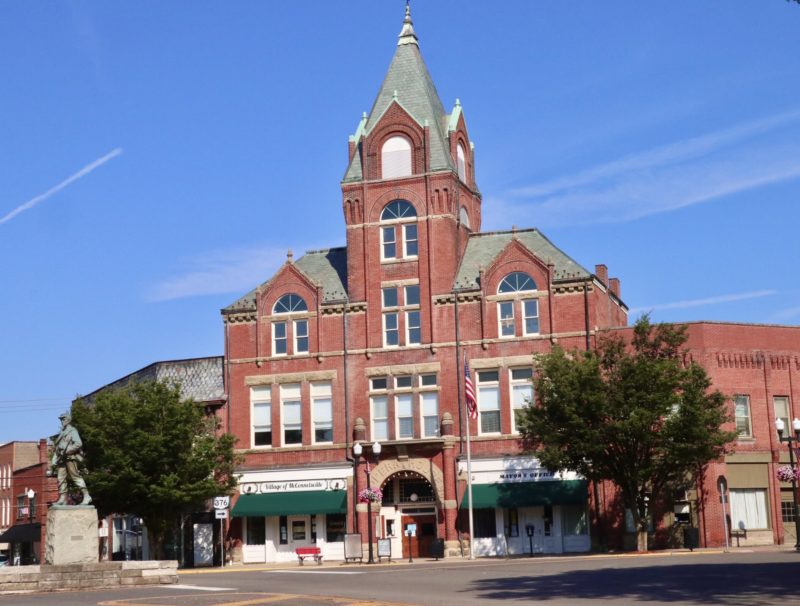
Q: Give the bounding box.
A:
[343,8,455,182]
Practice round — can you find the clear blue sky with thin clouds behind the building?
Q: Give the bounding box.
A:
[0,0,800,442]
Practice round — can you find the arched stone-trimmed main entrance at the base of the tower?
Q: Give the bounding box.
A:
[376,466,440,558]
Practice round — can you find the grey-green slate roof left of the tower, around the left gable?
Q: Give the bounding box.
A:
[222,248,347,313]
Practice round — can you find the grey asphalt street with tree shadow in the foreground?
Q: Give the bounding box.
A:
[0,549,800,606]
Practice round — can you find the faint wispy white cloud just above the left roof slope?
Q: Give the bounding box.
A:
[146,246,287,301]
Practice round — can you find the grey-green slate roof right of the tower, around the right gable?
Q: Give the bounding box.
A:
[453,229,591,290]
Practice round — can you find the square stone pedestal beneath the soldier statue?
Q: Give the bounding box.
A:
[44,505,99,566]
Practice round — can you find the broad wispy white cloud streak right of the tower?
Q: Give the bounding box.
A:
[488,112,800,227]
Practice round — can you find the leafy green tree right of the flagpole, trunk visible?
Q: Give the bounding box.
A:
[520,316,736,551]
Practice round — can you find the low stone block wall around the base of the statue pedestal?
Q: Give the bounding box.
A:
[0,560,178,594]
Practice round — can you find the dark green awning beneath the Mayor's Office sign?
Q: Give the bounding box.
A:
[461,480,587,509]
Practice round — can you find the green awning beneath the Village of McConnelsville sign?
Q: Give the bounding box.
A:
[231,490,347,518]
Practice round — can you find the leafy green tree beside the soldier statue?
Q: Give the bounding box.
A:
[72,381,238,558]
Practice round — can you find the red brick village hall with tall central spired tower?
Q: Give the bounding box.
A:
[222,7,627,562]
